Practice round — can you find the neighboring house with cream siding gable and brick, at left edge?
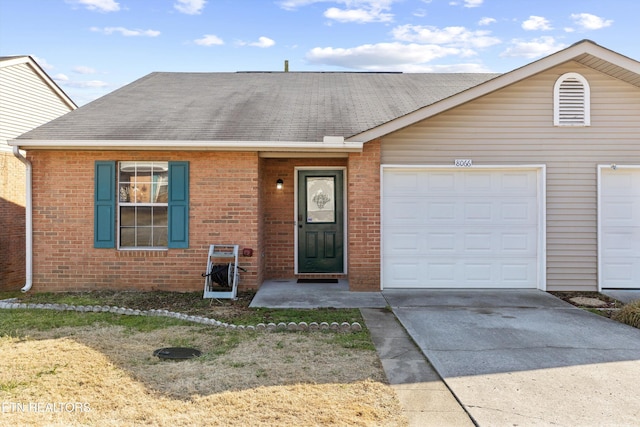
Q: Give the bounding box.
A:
[0,56,77,290]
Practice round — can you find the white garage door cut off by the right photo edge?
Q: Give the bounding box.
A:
[599,167,640,289]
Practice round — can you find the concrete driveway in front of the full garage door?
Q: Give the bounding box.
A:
[383,290,640,426]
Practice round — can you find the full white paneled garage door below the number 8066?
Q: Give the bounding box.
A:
[382,167,542,289]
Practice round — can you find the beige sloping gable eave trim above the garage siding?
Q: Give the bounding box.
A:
[347,40,640,142]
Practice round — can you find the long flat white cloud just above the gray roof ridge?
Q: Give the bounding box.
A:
[306,43,464,70]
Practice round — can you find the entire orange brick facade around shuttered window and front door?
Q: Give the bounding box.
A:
[29,147,380,291]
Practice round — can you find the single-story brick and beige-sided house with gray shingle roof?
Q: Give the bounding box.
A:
[11,41,640,291]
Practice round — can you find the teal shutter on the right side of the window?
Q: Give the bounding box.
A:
[169,162,189,248]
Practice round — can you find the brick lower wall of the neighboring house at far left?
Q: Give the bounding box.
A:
[0,151,26,291]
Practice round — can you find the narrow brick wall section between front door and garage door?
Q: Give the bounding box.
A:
[348,140,380,291]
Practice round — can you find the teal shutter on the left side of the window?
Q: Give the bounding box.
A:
[93,161,116,248]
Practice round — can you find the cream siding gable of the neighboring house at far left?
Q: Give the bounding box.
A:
[0,63,71,144]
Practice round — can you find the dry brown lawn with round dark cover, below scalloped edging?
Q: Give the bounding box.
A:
[0,326,406,426]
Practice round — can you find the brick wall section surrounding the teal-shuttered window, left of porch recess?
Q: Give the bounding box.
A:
[29,151,261,291]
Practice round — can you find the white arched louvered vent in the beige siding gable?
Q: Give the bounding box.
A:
[553,73,591,126]
